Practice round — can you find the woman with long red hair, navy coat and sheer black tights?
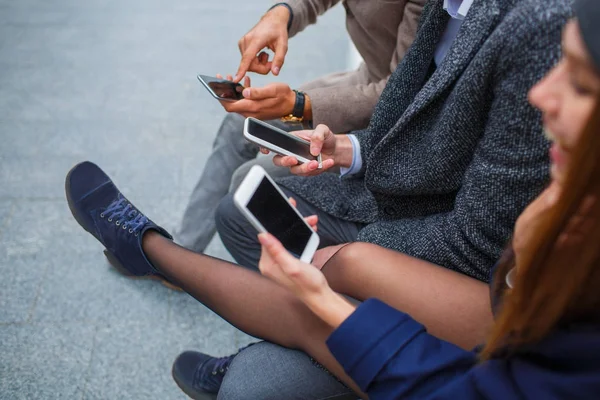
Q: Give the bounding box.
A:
[66,0,600,400]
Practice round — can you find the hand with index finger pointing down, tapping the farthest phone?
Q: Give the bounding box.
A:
[233,5,291,83]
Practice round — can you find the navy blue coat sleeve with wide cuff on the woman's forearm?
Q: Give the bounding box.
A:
[327,299,477,399]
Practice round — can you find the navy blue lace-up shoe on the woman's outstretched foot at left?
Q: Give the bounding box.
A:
[65,161,172,279]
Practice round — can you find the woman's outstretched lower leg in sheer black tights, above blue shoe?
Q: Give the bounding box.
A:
[142,231,366,398]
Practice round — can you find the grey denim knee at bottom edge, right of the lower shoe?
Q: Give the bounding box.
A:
[217,342,358,400]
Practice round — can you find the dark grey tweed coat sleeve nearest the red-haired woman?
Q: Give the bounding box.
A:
[358,14,565,281]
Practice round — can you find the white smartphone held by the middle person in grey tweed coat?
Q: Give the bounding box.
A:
[244,118,321,168]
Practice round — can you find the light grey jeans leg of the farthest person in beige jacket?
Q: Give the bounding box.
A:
[173,113,291,253]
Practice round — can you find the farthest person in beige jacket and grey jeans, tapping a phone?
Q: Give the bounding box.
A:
[174,0,426,253]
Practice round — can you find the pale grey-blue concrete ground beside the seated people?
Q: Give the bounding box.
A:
[0,0,349,399]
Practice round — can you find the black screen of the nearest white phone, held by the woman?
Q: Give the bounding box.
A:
[246,177,313,257]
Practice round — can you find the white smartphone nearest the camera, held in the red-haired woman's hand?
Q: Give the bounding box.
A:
[233,165,319,263]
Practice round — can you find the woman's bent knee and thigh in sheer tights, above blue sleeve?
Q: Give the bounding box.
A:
[323,242,493,349]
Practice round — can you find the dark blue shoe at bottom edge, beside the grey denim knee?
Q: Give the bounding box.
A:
[171,345,251,400]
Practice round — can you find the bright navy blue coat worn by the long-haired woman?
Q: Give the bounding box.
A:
[327,299,600,400]
